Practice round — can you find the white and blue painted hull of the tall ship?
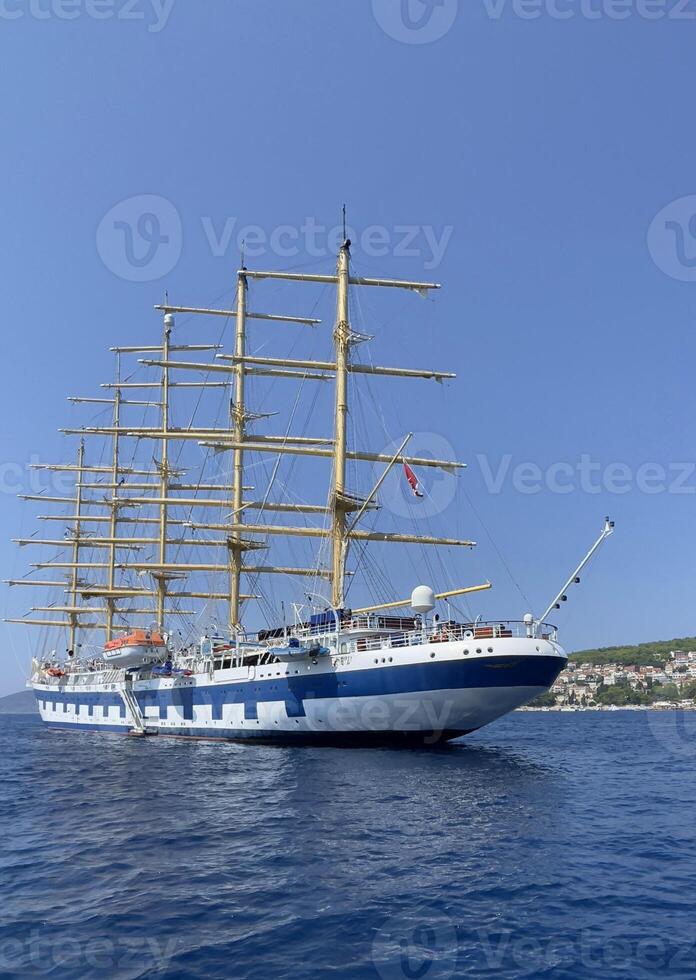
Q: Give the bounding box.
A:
[32,638,566,743]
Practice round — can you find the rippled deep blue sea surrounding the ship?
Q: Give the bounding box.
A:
[0,711,696,980]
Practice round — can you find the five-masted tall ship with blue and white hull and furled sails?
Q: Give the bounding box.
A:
[8,239,613,744]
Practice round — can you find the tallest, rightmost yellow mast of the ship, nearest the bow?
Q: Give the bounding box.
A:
[331,239,350,609]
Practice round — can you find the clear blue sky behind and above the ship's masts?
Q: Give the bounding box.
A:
[0,0,696,693]
